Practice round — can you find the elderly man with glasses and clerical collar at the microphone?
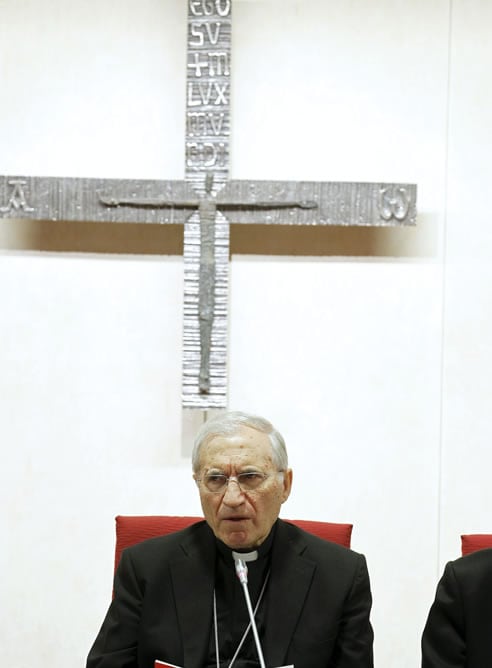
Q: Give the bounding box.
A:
[87,412,373,668]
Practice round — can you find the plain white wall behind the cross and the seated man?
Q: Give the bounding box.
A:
[0,0,492,668]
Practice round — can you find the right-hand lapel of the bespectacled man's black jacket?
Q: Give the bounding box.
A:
[264,520,316,666]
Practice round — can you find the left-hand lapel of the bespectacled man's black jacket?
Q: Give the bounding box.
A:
[171,523,215,668]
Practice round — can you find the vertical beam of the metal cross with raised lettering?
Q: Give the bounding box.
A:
[182,0,231,409]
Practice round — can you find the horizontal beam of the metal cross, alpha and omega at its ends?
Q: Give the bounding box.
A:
[0,176,417,226]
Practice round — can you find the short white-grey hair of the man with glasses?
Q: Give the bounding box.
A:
[191,411,289,473]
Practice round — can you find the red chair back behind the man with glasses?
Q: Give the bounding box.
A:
[114,515,353,570]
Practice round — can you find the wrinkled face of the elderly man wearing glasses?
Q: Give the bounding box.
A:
[195,426,292,550]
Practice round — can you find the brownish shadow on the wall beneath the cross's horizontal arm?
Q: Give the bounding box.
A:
[0,214,437,258]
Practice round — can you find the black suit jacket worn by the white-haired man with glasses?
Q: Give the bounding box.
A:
[87,520,373,668]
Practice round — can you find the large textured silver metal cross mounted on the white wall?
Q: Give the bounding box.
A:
[0,0,417,410]
